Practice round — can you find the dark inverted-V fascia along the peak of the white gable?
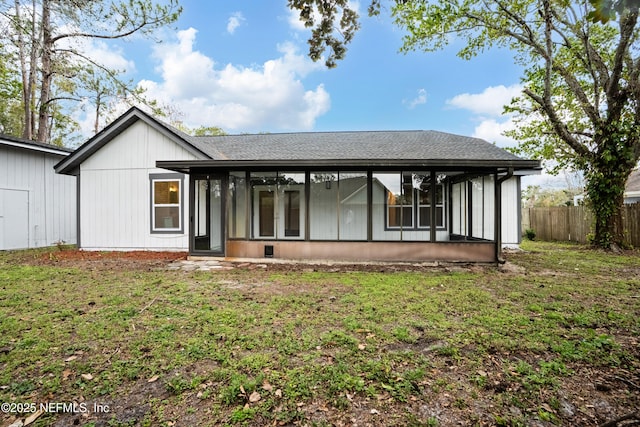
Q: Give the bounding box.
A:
[54,107,210,175]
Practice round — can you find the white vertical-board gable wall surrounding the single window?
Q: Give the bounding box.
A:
[80,121,196,251]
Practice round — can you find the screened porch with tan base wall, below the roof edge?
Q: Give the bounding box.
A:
[164,162,536,262]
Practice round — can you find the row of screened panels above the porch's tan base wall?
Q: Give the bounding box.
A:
[222,170,496,242]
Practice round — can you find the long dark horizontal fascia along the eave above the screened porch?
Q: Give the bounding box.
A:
[156,159,541,173]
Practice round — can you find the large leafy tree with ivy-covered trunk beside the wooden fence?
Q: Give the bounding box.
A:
[289,0,640,247]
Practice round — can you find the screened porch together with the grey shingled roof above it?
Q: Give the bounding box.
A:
[156,131,540,262]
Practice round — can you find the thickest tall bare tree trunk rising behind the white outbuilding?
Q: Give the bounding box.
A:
[36,0,53,142]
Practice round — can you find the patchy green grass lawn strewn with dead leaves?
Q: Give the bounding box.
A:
[0,242,640,426]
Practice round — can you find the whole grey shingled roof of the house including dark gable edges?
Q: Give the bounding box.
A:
[55,108,540,174]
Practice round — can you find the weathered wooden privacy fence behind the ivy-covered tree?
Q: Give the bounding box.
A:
[522,203,640,247]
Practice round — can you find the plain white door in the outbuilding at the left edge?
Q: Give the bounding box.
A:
[0,189,29,249]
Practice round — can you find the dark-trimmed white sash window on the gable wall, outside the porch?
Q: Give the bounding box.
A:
[149,174,184,233]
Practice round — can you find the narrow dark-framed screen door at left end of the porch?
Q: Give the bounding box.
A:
[191,175,225,256]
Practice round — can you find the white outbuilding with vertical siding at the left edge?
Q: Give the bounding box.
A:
[0,135,77,250]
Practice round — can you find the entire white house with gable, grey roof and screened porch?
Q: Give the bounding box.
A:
[55,108,540,262]
